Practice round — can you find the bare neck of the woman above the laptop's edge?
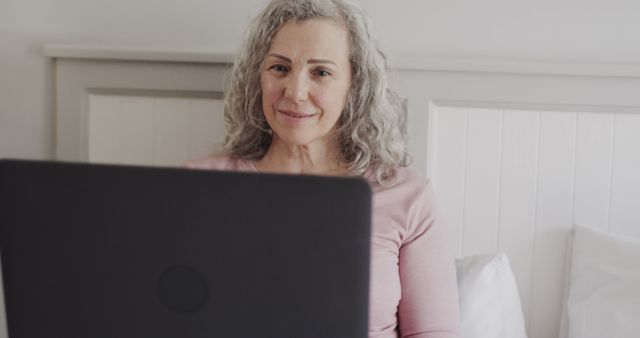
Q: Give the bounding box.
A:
[255,137,347,176]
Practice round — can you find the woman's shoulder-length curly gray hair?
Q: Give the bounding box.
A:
[222,0,409,185]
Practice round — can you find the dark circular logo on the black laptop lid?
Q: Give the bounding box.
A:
[158,265,209,313]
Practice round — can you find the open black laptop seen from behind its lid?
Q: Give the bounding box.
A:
[0,160,371,338]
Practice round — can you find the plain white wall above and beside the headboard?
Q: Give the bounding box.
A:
[0,0,640,159]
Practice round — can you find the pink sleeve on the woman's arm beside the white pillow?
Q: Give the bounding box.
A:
[398,184,460,338]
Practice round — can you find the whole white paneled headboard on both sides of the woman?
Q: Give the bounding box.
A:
[45,46,640,338]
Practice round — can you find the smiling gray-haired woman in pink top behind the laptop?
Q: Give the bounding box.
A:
[188,0,458,338]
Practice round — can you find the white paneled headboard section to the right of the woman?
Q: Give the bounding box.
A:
[395,60,640,338]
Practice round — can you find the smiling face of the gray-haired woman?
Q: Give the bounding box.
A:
[260,19,351,146]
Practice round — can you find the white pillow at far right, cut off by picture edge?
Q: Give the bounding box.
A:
[560,226,640,338]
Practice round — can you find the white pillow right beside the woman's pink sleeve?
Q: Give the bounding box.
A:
[456,253,527,338]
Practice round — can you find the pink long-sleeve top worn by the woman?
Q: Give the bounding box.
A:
[187,155,459,338]
